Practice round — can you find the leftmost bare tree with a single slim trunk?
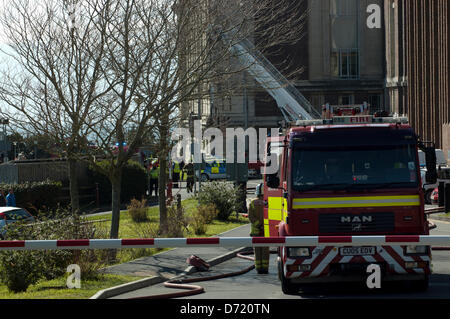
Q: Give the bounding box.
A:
[0,0,111,212]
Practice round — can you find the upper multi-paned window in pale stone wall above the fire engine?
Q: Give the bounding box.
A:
[331,49,359,79]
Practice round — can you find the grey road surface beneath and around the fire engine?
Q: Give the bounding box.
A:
[118,221,450,299]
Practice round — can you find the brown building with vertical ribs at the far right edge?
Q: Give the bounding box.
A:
[384,0,450,158]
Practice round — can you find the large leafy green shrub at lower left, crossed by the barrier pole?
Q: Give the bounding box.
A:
[0,208,104,292]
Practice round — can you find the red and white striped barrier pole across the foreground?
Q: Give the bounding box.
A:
[0,235,450,250]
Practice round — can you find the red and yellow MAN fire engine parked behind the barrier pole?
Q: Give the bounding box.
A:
[264,104,436,293]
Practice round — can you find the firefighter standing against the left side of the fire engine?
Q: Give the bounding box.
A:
[248,184,270,274]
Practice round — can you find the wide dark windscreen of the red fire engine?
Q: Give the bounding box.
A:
[292,144,419,191]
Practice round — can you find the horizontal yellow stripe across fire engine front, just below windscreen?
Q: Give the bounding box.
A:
[292,195,420,209]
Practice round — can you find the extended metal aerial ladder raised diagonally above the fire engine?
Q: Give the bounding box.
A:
[222,34,321,123]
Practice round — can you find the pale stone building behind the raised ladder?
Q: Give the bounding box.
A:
[181,0,385,132]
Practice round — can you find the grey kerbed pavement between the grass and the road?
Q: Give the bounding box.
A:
[91,224,250,299]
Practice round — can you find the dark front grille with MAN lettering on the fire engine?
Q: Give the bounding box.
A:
[319,212,395,234]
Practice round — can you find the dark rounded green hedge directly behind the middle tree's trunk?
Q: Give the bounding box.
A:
[89,160,148,204]
